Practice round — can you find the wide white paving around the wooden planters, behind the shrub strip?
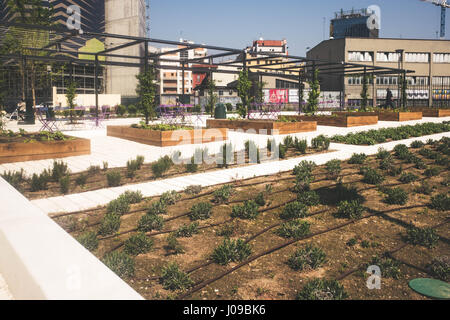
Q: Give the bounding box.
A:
[0,117,450,176]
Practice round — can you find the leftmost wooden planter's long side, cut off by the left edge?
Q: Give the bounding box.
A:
[0,138,91,164]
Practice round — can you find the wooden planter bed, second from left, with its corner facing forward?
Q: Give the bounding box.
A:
[106,126,228,147]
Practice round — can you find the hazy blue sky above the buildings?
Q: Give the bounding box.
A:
[150,0,450,55]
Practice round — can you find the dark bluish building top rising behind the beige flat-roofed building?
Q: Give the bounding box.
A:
[330,9,380,39]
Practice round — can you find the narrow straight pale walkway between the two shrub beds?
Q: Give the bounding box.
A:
[31,132,450,214]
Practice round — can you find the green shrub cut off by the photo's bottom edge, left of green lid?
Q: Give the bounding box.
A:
[297,278,348,300]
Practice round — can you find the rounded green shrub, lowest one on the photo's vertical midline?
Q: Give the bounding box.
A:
[211,238,252,265]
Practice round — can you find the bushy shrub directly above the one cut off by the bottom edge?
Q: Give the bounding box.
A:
[287,244,327,271]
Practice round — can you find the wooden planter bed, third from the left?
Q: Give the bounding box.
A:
[206,119,317,135]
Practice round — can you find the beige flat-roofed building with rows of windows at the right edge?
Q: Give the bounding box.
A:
[307,38,450,107]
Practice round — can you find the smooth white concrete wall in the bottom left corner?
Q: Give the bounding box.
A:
[0,178,142,300]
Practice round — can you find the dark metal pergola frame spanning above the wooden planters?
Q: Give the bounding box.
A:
[0,23,413,115]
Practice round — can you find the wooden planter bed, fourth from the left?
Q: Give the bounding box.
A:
[287,112,378,128]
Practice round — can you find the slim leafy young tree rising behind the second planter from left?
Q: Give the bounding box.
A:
[136,66,156,124]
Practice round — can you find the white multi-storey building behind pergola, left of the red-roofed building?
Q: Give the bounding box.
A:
[149,39,208,104]
